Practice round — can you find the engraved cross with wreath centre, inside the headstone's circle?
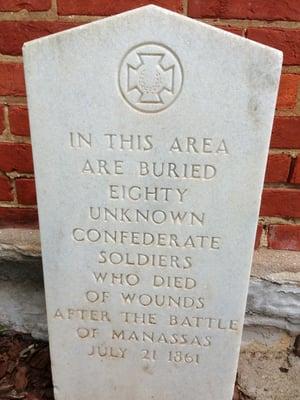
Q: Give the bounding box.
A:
[127,53,175,104]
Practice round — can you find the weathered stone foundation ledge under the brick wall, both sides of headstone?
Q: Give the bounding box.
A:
[0,229,300,339]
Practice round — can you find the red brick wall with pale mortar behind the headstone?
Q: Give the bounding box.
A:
[0,0,300,250]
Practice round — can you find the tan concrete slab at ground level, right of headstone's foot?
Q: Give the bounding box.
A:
[237,326,300,400]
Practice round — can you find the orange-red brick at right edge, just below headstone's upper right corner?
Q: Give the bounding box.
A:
[277,74,300,110]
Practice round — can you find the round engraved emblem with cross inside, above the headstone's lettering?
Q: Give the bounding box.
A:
[119,43,183,113]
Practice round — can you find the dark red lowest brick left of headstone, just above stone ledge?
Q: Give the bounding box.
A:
[0,207,38,228]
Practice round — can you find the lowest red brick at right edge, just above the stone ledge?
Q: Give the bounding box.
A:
[268,225,300,251]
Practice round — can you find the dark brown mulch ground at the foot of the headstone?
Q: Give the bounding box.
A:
[0,326,245,400]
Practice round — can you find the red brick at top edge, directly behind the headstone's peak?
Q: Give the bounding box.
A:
[57,0,183,16]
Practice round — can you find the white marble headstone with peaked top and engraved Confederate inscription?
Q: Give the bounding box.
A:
[24,6,282,400]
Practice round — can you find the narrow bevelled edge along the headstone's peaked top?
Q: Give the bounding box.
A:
[22,4,283,64]
